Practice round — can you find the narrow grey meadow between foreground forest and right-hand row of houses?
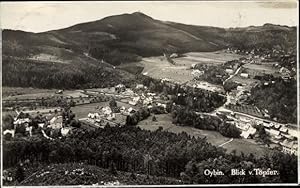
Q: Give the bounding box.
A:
[138,114,268,156]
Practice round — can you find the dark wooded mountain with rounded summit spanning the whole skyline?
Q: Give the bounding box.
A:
[2,12,297,87]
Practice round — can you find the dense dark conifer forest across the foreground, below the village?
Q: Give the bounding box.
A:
[3,126,297,184]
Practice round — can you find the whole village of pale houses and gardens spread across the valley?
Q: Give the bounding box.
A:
[3,44,299,158]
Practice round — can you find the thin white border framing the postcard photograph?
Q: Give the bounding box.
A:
[0,0,300,188]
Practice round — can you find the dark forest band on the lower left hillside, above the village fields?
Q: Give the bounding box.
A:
[2,58,134,89]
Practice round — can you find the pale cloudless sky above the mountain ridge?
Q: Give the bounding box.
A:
[0,0,298,32]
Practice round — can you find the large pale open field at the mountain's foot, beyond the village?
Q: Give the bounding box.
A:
[139,51,242,83]
